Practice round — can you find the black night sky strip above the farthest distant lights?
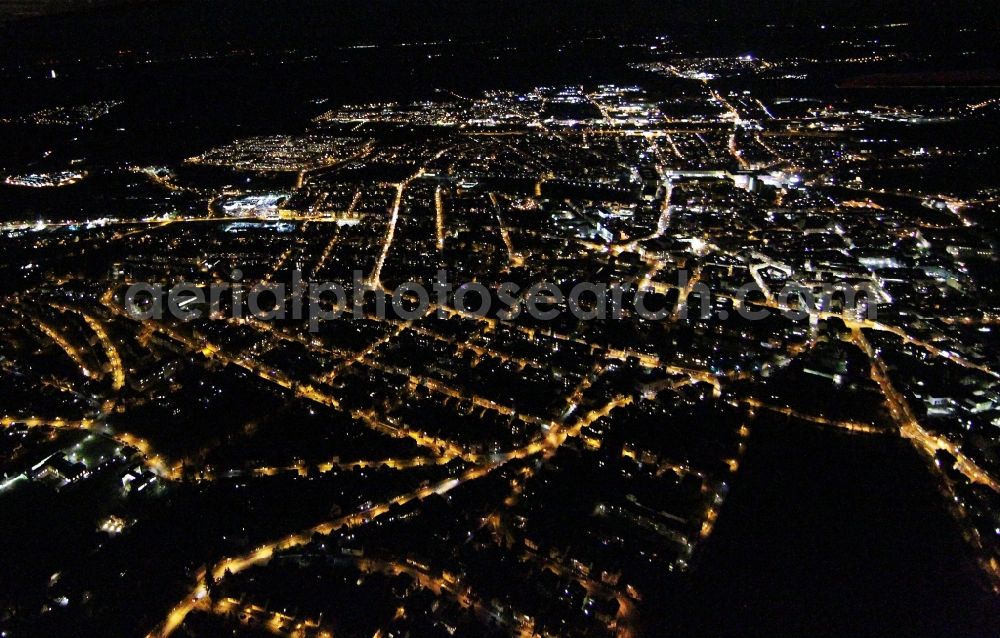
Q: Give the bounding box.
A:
[0,0,1000,55]
